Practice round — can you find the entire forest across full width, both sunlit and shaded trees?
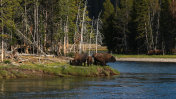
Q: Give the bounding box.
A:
[0,0,176,61]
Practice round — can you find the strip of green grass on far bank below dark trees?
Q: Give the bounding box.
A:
[113,54,176,58]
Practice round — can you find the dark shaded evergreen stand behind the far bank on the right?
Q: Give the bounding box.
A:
[102,0,176,54]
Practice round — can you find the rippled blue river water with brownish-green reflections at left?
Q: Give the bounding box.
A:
[0,62,176,99]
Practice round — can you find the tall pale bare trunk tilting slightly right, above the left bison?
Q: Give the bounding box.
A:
[79,0,87,53]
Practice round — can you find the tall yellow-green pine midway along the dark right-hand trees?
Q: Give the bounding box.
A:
[134,0,151,52]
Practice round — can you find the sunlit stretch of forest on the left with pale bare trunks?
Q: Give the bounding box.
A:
[0,0,102,61]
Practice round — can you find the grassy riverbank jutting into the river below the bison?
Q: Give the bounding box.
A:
[0,63,119,79]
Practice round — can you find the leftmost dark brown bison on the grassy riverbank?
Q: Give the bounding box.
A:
[72,53,88,66]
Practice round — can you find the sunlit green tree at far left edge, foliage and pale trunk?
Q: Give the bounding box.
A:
[0,0,20,61]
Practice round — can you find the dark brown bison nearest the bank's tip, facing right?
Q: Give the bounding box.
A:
[93,53,116,66]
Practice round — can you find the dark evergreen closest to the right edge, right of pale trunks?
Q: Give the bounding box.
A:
[159,0,175,53]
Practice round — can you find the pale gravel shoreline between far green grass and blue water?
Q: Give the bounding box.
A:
[116,57,176,63]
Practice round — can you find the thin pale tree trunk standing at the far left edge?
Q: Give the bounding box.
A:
[1,0,4,62]
